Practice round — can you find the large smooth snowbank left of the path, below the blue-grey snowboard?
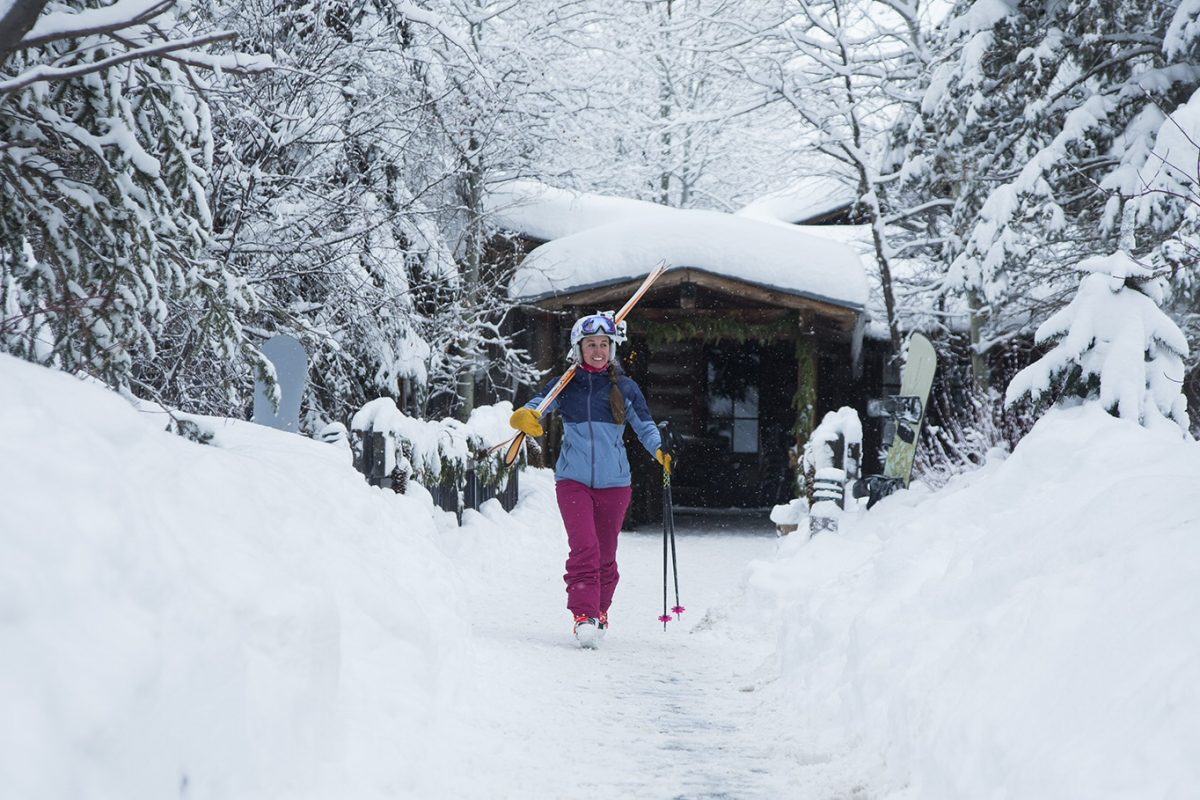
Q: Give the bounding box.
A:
[0,355,470,800]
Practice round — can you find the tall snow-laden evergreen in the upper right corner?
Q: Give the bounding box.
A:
[908,0,1200,383]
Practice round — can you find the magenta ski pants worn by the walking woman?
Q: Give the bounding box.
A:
[554,481,632,616]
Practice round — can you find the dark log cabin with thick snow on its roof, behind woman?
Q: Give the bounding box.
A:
[496,181,894,525]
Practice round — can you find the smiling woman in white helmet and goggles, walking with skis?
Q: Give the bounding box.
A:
[510,314,671,648]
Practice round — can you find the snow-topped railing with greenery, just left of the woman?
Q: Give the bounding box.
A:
[350,397,526,519]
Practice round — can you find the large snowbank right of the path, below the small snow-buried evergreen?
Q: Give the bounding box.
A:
[748,405,1200,800]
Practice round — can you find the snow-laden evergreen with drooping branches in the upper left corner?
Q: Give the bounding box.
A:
[0,0,265,398]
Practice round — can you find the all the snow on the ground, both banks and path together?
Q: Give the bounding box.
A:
[0,356,1200,800]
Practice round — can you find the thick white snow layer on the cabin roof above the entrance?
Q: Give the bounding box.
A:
[491,181,868,309]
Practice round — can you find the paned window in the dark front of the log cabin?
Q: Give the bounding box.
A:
[707,345,760,453]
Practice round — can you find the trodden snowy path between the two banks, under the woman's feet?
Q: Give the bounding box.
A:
[436,501,856,799]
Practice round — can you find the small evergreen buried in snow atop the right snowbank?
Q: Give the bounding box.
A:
[1006,251,1188,433]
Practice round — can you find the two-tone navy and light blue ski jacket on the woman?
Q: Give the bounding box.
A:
[526,366,662,489]
